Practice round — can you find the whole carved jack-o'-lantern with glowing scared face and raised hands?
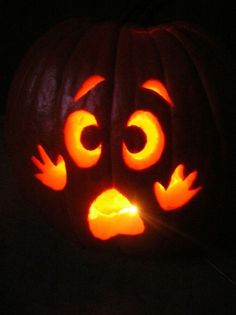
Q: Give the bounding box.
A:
[8,20,230,252]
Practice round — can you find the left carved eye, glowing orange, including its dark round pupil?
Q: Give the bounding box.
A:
[64,110,102,168]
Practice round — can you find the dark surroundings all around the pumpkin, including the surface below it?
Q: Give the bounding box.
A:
[0,0,236,315]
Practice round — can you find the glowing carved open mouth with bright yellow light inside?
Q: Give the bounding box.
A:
[88,188,145,240]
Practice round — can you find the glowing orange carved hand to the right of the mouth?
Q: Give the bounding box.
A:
[154,164,202,211]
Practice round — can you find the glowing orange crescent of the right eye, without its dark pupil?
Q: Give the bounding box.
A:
[122,110,165,170]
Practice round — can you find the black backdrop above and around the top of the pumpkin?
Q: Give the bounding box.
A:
[0,0,236,114]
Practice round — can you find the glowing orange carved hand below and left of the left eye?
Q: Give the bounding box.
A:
[31,144,67,191]
